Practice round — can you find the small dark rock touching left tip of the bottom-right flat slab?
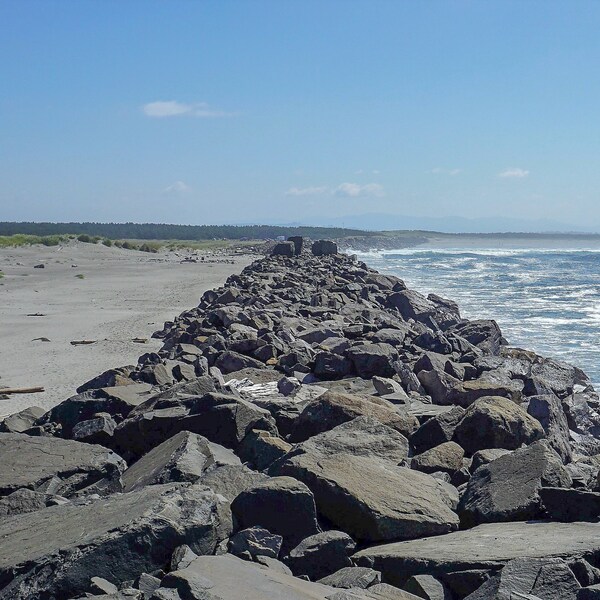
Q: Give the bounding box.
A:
[286,531,356,580]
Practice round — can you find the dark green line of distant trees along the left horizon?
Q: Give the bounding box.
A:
[0,222,377,242]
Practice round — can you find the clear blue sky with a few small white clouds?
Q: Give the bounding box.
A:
[0,0,600,231]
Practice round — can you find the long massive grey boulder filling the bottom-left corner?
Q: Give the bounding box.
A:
[0,485,231,600]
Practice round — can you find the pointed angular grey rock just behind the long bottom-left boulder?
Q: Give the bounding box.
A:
[122,431,215,492]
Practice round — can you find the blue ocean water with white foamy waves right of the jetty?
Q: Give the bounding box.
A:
[356,244,600,389]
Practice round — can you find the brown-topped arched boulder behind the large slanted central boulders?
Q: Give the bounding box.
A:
[291,391,419,442]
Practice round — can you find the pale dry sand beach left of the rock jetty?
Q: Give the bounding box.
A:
[0,242,252,416]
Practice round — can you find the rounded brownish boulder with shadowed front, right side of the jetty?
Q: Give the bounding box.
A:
[454,396,545,454]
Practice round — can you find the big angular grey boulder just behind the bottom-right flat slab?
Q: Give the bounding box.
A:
[459,441,572,526]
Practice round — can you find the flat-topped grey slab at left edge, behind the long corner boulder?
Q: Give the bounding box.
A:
[0,433,127,496]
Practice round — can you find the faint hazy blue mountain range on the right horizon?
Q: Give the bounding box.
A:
[278,213,600,233]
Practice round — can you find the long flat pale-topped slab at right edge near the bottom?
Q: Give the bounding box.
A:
[354,521,600,586]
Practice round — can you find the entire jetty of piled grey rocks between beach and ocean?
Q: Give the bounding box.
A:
[0,238,600,600]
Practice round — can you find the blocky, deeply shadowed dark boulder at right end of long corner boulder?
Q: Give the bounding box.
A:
[231,477,319,548]
